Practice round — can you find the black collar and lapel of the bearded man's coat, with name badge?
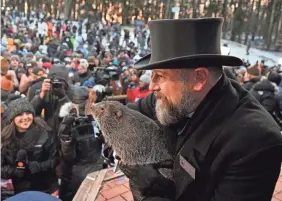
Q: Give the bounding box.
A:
[174,75,239,199]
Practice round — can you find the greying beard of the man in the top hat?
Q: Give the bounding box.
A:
[155,89,196,125]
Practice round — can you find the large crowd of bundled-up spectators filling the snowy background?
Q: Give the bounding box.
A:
[1,7,282,201]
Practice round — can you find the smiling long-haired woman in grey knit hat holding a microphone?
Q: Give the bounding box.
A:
[1,98,58,194]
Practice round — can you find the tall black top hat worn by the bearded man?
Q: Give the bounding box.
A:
[135,18,242,70]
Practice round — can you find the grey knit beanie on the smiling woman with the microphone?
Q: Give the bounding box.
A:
[8,98,35,122]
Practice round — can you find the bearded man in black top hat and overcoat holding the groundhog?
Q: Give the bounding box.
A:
[121,18,282,201]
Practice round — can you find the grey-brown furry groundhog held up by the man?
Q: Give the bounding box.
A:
[91,101,172,179]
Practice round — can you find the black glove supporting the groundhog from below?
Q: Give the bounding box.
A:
[120,161,176,200]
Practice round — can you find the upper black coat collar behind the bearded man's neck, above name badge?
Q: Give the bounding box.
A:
[177,74,239,156]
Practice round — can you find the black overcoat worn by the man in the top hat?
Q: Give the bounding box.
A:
[128,75,282,201]
